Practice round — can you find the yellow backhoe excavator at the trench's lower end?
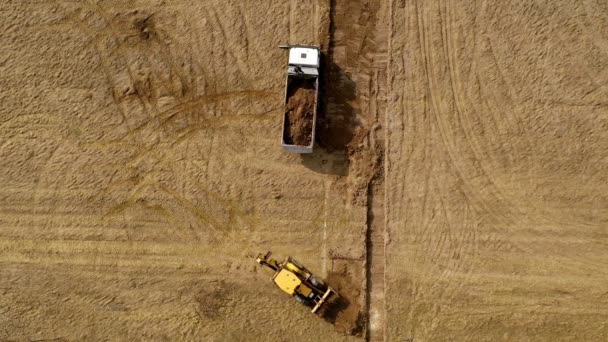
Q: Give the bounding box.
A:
[256,252,338,313]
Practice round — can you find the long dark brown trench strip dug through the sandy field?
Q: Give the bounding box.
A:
[325,0,390,341]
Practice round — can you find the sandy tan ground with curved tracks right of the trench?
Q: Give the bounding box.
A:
[385,1,608,341]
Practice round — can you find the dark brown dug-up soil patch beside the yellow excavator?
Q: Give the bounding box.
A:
[322,272,365,336]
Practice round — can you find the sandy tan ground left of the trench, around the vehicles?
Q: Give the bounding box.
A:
[0,1,366,341]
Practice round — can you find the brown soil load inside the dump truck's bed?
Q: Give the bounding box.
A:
[285,79,315,146]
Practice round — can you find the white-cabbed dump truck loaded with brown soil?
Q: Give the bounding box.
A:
[279,45,321,153]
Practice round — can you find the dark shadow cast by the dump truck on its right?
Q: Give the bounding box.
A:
[302,55,357,176]
